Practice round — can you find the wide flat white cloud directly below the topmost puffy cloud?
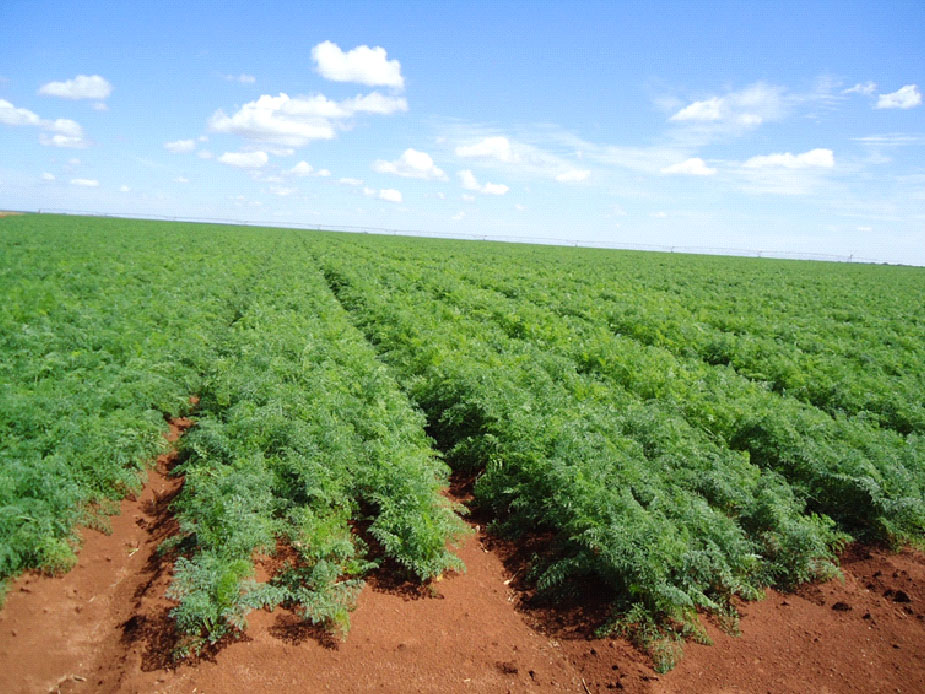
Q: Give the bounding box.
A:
[209,92,408,147]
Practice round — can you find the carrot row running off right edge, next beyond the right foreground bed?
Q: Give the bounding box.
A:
[328,238,925,543]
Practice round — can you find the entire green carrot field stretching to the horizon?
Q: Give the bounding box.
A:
[0,215,925,667]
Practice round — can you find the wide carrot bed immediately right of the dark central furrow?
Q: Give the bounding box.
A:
[319,239,841,667]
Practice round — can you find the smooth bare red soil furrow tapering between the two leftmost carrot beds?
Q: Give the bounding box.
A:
[0,418,192,694]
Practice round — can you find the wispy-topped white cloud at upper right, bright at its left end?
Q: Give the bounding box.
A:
[669,82,785,128]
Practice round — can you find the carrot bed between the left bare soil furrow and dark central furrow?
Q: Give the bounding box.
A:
[168,237,465,653]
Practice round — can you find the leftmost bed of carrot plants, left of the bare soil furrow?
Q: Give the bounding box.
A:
[0,216,247,581]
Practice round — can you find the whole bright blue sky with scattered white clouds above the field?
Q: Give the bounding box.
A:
[0,0,925,265]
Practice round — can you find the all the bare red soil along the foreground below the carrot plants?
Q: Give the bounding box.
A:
[0,420,925,694]
